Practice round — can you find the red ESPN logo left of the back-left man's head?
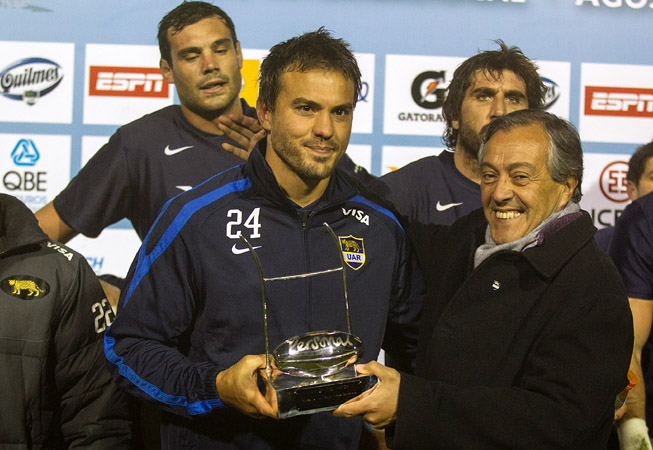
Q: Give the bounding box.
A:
[88,66,170,98]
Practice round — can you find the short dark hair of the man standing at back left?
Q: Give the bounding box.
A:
[157,1,238,65]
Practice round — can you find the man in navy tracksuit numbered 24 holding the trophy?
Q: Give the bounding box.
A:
[105,29,423,449]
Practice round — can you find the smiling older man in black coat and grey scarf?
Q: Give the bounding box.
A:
[335,110,633,450]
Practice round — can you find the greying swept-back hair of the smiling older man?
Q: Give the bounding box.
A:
[478,109,583,203]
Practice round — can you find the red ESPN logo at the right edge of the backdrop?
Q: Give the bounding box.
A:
[585,86,653,117]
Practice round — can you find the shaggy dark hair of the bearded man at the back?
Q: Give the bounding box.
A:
[442,39,546,149]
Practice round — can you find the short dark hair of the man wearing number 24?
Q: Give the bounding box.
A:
[258,27,361,111]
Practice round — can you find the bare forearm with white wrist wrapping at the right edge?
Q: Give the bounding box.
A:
[618,298,653,450]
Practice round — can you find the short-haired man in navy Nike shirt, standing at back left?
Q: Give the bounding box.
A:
[36,1,369,304]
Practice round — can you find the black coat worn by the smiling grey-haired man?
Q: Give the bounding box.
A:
[389,210,633,450]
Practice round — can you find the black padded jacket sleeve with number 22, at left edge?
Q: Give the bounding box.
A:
[53,250,131,450]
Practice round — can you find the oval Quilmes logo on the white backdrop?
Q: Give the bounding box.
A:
[0,58,63,105]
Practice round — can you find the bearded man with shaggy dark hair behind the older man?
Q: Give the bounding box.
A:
[371,40,546,229]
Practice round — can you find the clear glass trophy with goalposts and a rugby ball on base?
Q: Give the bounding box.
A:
[240,222,378,419]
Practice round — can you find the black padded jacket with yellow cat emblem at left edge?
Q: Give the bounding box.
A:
[0,194,130,449]
